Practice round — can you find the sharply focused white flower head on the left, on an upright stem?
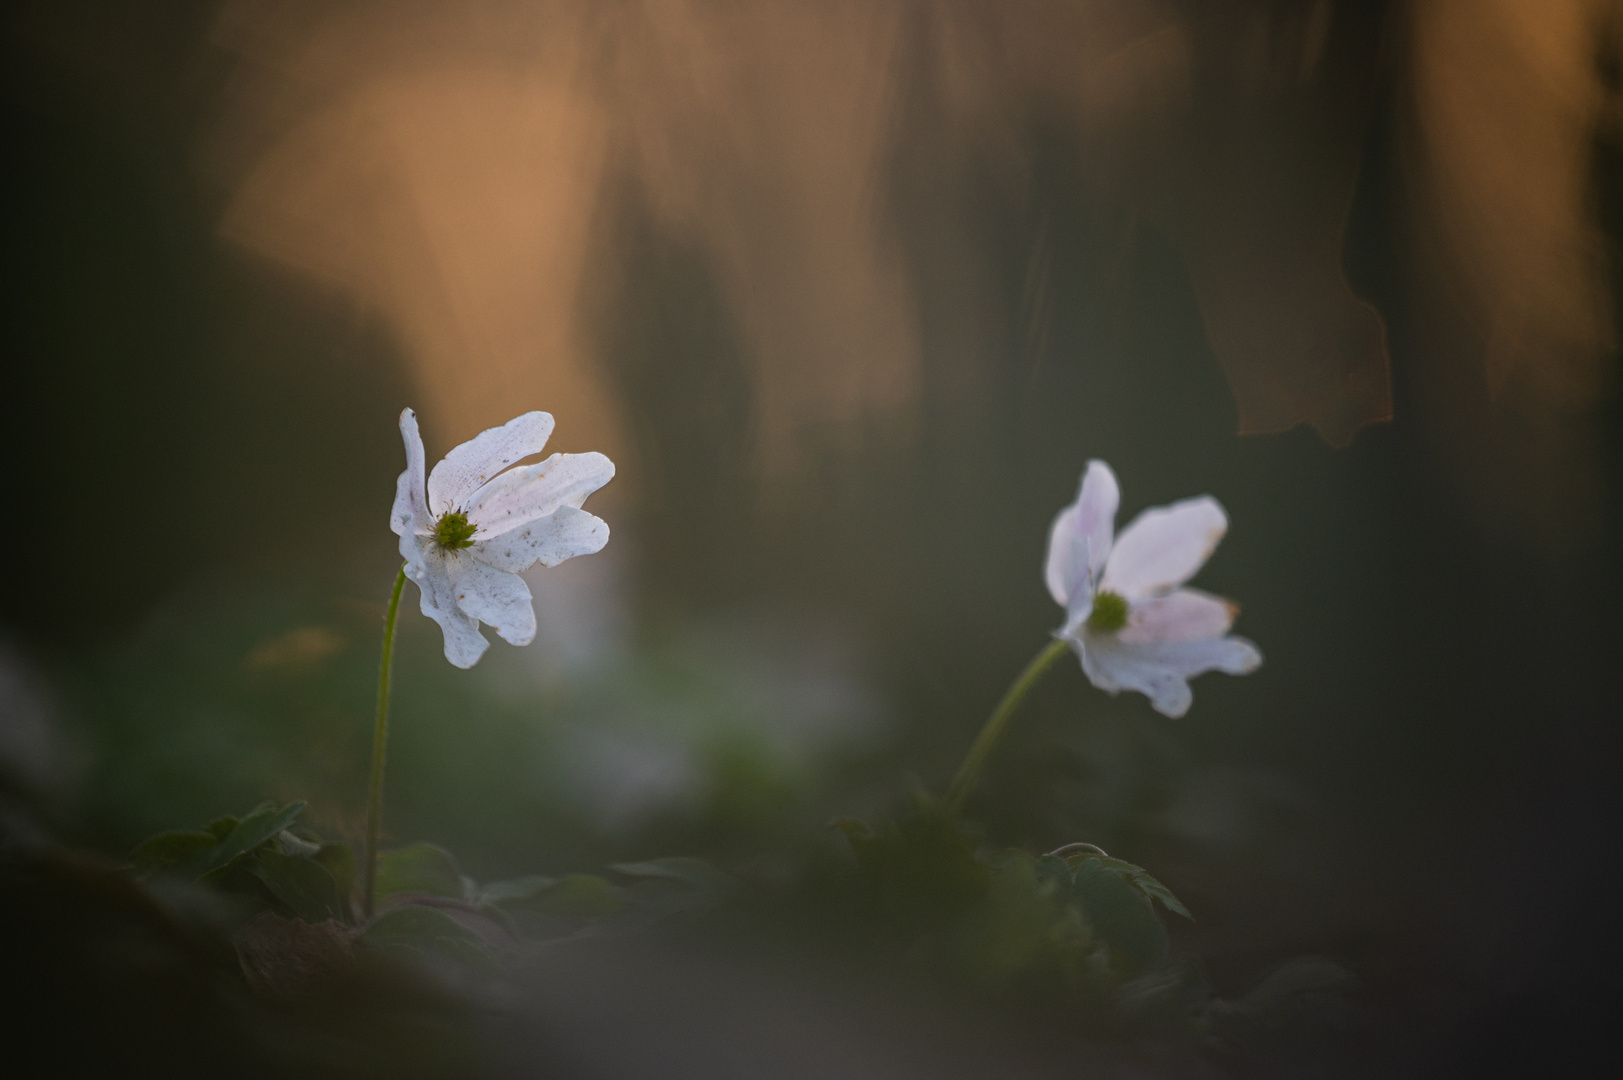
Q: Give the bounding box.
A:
[390,409,613,667]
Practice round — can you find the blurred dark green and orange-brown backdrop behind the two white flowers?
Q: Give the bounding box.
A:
[0,0,1623,1075]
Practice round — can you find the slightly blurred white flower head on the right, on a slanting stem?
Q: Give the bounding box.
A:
[1045,461,1263,716]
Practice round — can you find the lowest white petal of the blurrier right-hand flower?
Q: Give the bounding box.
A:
[1073,630,1263,718]
